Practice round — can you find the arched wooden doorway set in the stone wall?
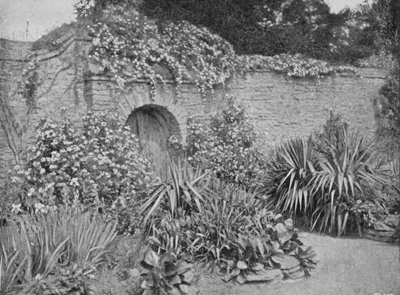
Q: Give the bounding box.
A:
[126,104,181,180]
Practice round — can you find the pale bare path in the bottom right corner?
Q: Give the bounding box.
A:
[190,233,400,295]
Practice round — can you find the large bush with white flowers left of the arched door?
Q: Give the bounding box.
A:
[10,112,154,235]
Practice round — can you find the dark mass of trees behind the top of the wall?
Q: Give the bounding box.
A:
[76,0,395,63]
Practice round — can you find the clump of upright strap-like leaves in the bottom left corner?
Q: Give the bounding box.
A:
[0,208,117,295]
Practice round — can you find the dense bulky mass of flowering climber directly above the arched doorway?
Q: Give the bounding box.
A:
[85,5,240,97]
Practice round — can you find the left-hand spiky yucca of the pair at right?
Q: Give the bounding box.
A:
[266,139,315,213]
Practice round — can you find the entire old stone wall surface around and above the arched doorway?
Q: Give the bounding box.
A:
[0,40,386,179]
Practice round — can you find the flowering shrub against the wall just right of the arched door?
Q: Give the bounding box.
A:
[186,97,265,187]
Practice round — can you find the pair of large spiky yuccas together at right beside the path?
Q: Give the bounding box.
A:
[265,113,390,235]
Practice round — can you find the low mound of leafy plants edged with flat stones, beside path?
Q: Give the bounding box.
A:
[144,176,317,284]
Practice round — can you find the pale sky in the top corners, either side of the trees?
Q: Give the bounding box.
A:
[0,0,364,41]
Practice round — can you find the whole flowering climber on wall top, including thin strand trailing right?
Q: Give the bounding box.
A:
[79,0,356,100]
